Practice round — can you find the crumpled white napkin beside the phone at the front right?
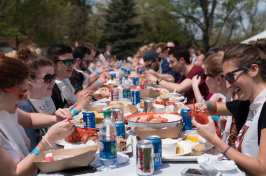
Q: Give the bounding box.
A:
[198,154,245,176]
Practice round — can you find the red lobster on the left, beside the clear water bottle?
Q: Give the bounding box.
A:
[66,128,98,142]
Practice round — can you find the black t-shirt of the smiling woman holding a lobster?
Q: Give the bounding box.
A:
[226,100,266,145]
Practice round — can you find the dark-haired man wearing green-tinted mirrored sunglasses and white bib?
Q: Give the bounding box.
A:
[46,44,97,110]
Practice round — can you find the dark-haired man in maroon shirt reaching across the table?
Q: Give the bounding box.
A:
[147,47,212,104]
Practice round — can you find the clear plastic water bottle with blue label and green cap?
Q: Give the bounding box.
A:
[99,110,117,170]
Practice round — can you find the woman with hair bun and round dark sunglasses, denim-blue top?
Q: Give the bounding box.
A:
[18,48,90,150]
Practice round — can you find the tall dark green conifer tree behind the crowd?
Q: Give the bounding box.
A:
[100,0,141,59]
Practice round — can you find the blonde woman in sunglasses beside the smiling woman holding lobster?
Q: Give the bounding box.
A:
[192,53,232,141]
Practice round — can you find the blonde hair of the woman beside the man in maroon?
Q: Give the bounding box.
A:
[204,53,224,76]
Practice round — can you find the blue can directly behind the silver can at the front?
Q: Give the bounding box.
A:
[146,135,162,169]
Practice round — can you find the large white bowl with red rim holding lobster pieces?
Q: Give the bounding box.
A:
[124,113,182,131]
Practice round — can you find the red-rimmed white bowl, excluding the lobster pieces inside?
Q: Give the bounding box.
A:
[124,113,182,131]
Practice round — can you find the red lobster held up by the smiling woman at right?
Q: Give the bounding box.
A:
[187,99,221,138]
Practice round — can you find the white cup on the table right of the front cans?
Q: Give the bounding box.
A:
[162,139,177,156]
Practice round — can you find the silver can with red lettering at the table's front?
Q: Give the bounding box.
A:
[136,140,154,175]
